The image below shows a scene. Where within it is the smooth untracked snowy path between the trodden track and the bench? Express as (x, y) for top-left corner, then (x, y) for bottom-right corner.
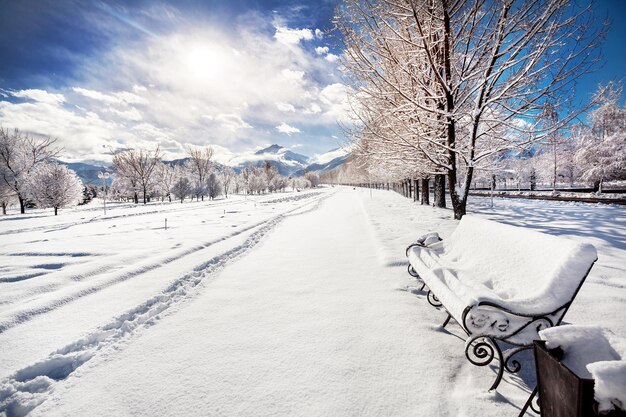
(7, 192), (468, 416)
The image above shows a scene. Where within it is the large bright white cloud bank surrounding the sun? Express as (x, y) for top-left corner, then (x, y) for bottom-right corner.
(0, 16), (343, 159)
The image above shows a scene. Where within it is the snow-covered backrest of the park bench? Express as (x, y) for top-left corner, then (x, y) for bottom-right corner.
(443, 216), (597, 312)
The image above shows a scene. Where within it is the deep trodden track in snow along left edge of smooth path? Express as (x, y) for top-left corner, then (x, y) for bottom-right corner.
(0, 193), (332, 417)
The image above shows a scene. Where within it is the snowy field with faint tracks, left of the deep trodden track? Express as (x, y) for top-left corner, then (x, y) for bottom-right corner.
(0, 193), (324, 390)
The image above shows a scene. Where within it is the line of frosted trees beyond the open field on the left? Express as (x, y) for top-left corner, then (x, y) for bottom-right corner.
(0, 127), (319, 215)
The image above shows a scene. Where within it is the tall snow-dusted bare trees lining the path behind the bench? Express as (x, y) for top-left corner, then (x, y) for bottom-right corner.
(335, 0), (607, 219)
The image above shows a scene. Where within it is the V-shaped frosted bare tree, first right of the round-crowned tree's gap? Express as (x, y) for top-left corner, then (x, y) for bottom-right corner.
(113, 145), (161, 204)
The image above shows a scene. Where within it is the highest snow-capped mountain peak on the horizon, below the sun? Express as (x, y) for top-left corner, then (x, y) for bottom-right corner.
(227, 144), (309, 177)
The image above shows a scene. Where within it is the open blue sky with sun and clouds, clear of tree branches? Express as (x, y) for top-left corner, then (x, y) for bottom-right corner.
(0, 0), (626, 161)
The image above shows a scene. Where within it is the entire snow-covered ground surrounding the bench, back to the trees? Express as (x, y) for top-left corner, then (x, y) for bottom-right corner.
(0, 187), (626, 416)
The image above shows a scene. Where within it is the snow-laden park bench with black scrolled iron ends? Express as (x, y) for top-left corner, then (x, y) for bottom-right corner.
(406, 216), (597, 389)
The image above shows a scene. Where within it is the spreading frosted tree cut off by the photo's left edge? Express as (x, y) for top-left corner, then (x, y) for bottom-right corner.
(0, 126), (60, 213)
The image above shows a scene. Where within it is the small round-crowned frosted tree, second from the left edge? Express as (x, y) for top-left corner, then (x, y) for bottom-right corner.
(26, 162), (83, 216)
